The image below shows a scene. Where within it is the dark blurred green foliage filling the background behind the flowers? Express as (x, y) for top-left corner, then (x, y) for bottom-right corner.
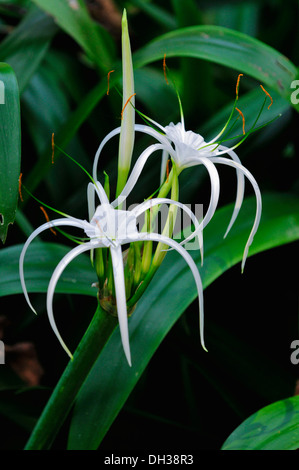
(0, 0), (299, 451)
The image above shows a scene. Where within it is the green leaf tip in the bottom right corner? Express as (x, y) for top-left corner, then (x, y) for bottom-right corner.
(222, 396), (299, 450)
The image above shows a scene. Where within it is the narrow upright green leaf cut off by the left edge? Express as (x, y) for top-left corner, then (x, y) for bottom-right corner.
(0, 63), (21, 243)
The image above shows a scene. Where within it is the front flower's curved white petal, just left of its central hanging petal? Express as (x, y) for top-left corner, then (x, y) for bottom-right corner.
(47, 242), (102, 359)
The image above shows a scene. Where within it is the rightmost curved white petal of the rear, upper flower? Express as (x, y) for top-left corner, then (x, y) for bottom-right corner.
(211, 157), (262, 272)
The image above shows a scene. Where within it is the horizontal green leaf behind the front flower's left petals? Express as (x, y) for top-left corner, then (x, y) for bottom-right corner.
(0, 243), (97, 298)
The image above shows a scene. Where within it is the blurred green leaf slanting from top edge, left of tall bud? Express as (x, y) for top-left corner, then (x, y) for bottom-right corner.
(33, 0), (113, 73)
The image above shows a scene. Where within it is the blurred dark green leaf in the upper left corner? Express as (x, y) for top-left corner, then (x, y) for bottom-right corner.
(0, 6), (57, 93)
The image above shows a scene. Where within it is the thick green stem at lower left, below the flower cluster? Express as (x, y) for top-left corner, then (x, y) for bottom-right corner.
(25, 304), (117, 450)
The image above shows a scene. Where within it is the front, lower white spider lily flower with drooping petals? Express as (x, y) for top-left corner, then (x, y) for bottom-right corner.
(19, 182), (206, 366)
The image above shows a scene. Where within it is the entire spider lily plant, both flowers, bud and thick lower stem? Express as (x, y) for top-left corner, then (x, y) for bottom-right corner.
(20, 12), (284, 449)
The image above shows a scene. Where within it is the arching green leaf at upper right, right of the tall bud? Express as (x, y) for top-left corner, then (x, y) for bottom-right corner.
(134, 25), (298, 107)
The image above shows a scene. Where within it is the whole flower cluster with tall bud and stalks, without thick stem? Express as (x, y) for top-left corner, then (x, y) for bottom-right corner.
(20, 12), (276, 372)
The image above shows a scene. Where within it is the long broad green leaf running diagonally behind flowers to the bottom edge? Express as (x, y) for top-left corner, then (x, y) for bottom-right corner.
(68, 194), (299, 450)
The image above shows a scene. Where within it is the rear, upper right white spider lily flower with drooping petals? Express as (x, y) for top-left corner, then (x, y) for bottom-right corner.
(93, 117), (262, 271)
